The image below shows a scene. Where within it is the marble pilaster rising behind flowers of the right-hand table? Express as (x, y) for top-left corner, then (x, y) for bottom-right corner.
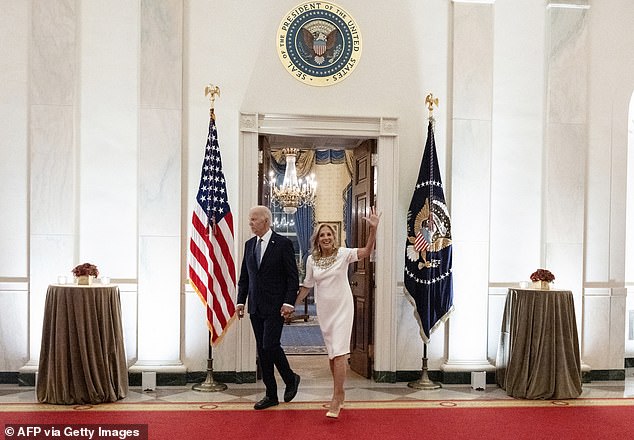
(543, 1), (589, 322)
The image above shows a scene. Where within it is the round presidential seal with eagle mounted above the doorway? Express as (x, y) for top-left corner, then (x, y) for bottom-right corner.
(277, 1), (362, 86)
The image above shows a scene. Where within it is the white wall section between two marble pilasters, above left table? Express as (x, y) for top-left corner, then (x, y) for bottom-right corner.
(79, 0), (142, 280)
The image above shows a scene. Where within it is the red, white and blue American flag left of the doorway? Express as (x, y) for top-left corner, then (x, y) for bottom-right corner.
(188, 109), (236, 345)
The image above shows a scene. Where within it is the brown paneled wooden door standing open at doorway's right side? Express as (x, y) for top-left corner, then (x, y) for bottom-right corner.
(350, 139), (376, 378)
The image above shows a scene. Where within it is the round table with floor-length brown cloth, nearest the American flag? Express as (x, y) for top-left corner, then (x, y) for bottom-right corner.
(36, 284), (128, 404)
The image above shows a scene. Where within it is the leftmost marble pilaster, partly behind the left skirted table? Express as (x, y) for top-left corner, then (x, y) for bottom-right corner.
(21, 0), (78, 372)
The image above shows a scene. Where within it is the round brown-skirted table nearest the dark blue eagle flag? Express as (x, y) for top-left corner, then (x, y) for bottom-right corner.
(496, 288), (581, 399)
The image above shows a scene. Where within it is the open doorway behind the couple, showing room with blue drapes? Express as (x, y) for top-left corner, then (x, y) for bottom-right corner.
(258, 135), (376, 370)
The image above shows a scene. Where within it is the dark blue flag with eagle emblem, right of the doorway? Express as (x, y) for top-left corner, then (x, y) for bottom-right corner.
(404, 118), (453, 343)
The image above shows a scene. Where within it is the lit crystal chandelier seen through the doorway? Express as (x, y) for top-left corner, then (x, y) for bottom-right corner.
(269, 148), (317, 214)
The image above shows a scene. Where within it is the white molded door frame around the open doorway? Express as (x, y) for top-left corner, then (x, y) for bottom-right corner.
(236, 112), (402, 373)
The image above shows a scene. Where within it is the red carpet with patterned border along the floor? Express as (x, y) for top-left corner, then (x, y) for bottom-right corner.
(0, 399), (634, 440)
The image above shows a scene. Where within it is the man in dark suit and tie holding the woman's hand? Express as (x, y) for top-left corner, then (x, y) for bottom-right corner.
(237, 206), (300, 409)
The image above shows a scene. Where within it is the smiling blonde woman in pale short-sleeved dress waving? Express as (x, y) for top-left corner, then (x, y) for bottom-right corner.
(297, 208), (380, 418)
